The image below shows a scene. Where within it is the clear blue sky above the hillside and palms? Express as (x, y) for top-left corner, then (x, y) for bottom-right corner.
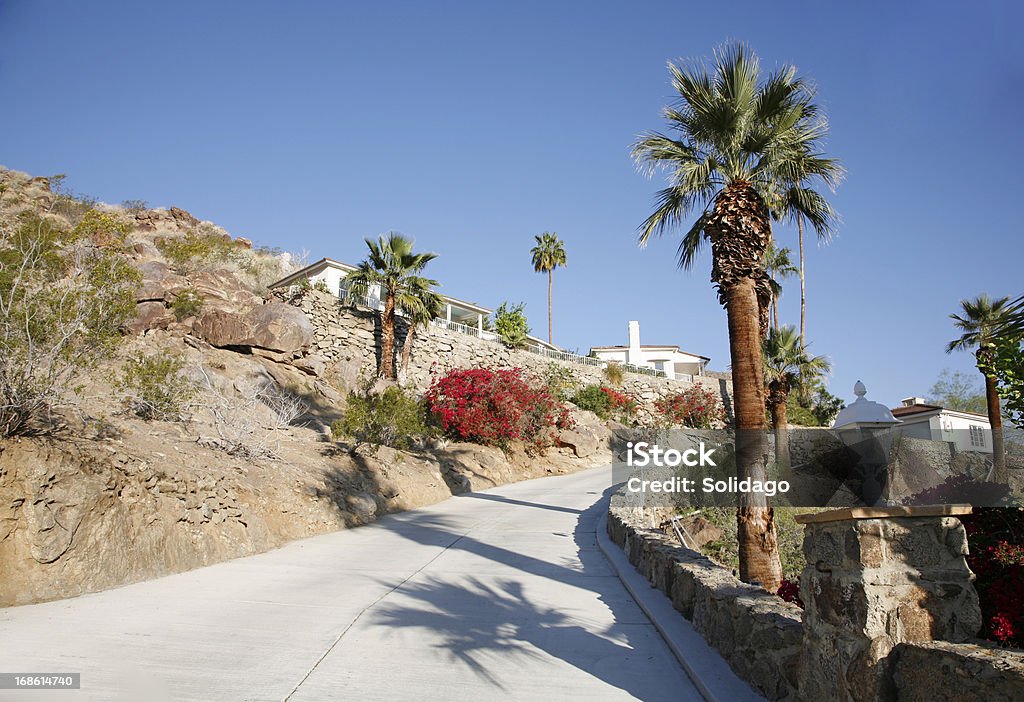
(0, 0), (1024, 403)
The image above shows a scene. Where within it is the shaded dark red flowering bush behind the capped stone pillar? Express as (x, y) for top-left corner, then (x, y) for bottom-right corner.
(961, 508), (1024, 648)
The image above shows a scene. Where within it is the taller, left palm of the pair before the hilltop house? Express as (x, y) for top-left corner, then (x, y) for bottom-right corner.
(344, 231), (437, 379)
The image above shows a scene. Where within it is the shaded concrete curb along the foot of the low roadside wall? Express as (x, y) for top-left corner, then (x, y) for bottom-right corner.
(597, 500), (765, 702)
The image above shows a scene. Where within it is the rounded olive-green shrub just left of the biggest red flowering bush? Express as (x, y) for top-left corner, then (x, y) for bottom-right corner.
(331, 387), (435, 448)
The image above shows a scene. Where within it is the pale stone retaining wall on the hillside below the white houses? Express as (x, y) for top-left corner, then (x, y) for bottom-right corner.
(280, 290), (732, 424)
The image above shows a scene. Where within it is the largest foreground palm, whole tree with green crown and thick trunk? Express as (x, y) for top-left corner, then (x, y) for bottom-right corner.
(633, 44), (831, 590)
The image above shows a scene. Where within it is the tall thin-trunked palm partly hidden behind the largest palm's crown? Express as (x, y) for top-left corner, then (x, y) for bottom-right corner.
(776, 151), (845, 346)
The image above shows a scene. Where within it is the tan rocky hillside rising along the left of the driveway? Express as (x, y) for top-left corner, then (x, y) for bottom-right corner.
(0, 169), (610, 606)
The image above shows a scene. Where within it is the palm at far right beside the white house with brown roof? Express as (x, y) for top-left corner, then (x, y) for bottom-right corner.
(946, 295), (1016, 483)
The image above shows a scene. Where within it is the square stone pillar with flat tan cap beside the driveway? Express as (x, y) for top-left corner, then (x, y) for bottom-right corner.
(797, 506), (981, 702)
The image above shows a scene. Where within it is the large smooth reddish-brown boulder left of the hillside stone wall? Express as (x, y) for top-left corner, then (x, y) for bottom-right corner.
(194, 302), (313, 353)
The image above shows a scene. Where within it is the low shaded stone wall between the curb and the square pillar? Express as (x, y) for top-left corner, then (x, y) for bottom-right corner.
(608, 492), (804, 700)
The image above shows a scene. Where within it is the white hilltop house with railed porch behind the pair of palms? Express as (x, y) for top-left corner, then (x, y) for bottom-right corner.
(269, 258), (561, 351)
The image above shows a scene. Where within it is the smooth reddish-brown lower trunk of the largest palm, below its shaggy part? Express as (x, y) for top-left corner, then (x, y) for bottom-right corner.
(726, 277), (782, 593)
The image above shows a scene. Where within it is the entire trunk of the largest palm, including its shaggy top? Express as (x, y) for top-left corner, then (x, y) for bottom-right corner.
(705, 181), (782, 593)
